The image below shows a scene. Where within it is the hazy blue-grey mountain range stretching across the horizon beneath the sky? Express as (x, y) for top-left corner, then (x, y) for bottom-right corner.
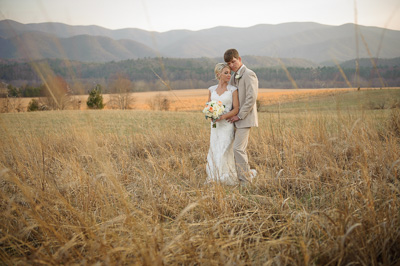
(0, 20), (400, 64)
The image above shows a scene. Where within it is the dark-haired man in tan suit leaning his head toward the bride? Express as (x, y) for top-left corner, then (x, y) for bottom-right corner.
(224, 49), (258, 184)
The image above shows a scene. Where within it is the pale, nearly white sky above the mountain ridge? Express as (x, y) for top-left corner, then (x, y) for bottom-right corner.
(0, 0), (400, 32)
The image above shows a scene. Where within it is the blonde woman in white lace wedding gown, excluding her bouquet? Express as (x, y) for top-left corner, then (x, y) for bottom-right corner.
(206, 63), (239, 185)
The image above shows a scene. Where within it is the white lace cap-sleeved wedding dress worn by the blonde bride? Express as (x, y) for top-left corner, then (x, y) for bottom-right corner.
(206, 85), (238, 185)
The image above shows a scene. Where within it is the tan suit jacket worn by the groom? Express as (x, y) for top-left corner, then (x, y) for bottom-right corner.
(230, 65), (258, 128)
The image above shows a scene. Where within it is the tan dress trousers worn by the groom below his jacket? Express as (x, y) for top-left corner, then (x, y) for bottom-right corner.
(233, 127), (250, 183)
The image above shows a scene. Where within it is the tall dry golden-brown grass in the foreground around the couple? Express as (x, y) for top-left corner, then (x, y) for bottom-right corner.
(0, 89), (400, 265)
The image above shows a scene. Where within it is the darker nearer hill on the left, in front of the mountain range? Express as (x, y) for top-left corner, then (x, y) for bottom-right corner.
(0, 32), (157, 62)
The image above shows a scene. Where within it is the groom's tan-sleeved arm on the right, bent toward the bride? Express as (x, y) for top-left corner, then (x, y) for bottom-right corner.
(238, 71), (258, 119)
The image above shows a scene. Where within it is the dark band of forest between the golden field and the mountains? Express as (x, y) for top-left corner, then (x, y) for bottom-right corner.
(0, 58), (400, 94)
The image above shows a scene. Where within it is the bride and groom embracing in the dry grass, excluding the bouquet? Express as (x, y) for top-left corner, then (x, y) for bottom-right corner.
(206, 49), (258, 185)
